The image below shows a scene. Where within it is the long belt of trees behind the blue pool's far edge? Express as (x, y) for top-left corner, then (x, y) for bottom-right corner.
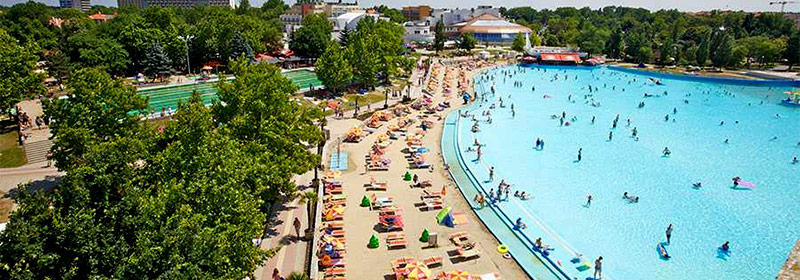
(500, 7), (800, 67)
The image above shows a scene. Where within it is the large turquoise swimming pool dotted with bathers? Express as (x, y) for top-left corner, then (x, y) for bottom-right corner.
(454, 66), (800, 279)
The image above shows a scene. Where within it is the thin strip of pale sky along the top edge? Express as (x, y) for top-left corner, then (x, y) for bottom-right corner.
(0, 0), (800, 12)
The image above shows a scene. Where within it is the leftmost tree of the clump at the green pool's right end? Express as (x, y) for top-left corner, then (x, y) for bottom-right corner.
(314, 44), (353, 93)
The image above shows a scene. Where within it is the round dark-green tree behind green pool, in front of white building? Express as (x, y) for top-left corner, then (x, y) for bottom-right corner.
(289, 14), (333, 58)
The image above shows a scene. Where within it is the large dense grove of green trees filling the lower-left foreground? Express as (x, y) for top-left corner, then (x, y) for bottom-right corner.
(0, 59), (322, 279)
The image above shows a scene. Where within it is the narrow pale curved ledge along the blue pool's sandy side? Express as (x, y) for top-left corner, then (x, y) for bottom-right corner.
(443, 75), (572, 279)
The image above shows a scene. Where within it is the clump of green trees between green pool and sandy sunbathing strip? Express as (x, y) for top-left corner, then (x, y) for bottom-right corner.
(306, 16), (406, 92)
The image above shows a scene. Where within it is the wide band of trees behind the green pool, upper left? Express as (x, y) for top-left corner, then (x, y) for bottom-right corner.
(0, 0), (287, 79)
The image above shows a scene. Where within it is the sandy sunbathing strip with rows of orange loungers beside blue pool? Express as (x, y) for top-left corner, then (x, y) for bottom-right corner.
(314, 57), (528, 279)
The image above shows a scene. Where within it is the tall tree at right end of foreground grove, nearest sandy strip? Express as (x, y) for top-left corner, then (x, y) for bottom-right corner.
(213, 59), (322, 201)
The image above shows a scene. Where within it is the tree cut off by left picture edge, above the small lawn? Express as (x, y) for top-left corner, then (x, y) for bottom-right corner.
(0, 29), (44, 113)
